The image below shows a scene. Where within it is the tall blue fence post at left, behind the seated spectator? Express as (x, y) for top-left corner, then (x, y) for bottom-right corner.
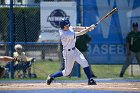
(10, 0), (14, 79)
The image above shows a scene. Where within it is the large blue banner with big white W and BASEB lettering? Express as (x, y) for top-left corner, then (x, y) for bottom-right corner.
(83, 0), (140, 64)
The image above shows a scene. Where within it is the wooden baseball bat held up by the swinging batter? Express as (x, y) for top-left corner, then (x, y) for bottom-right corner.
(89, 8), (118, 28)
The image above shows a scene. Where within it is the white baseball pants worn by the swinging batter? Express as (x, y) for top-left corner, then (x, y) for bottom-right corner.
(62, 48), (89, 76)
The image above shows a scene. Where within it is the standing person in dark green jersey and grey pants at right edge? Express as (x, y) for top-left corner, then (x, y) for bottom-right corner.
(120, 23), (140, 77)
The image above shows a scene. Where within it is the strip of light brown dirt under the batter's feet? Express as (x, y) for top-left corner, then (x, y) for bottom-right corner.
(0, 82), (140, 92)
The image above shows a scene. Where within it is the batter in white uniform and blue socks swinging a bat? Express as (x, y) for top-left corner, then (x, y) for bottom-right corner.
(46, 19), (96, 85)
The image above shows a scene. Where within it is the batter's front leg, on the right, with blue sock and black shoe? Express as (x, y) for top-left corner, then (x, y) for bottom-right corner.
(75, 49), (96, 85)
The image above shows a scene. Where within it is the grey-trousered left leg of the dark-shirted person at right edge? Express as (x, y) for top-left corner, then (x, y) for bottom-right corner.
(120, 52), (135, 77)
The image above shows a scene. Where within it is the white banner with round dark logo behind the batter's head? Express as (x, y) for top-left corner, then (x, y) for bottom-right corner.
(39, 2), (77, 42)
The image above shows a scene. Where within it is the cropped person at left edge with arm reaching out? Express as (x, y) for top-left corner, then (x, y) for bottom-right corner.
(0, 56), (14, 78)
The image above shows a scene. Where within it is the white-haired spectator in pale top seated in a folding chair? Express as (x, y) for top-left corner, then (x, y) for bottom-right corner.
(5, 44), (33, 78)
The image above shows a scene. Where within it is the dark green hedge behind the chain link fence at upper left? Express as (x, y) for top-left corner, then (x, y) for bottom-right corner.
(0, 7), (40, 42)
